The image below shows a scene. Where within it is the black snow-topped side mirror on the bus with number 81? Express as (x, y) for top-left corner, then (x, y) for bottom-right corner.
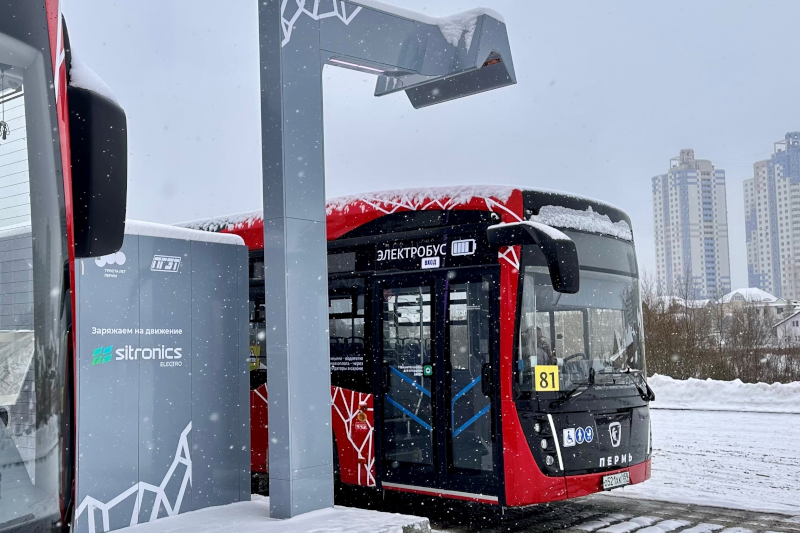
(486, 222), (580, 294)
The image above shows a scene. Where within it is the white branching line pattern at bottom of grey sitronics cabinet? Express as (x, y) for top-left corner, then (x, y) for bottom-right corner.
(75, 422), (192, 533)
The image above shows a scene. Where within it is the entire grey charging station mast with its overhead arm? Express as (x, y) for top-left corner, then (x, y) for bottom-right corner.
(259, 0), (516, 518)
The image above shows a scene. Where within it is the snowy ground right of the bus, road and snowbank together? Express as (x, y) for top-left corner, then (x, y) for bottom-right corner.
(611, 375), (800, 515)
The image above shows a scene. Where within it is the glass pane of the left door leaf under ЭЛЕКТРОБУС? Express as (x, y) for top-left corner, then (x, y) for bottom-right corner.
(381, 286), (434, 468)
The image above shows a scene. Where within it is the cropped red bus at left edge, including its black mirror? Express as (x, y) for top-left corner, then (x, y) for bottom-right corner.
(0, 0), (127, 531)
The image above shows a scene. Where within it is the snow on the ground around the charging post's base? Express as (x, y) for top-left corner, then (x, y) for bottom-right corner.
(123, 494), (430, 533)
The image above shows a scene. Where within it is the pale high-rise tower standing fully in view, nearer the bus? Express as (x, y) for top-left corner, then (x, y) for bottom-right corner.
(653, 149), (731, 298)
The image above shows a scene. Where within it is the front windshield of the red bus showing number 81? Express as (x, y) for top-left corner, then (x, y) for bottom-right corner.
(517, 231), (645, 393)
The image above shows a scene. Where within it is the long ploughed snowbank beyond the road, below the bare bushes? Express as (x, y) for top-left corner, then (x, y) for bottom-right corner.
(647, 374), (800, 414)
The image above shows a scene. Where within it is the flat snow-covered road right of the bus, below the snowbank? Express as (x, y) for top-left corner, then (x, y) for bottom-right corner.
(610, 409), (800, 515)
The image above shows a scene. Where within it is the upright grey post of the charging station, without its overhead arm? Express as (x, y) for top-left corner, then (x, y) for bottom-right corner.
(259, 1), (333, 518)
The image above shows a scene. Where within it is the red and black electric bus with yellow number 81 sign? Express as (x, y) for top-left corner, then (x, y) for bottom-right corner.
(186, 186), (654, 506)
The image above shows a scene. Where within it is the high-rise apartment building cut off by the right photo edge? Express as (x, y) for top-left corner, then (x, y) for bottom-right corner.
(744, 131), (800, 300)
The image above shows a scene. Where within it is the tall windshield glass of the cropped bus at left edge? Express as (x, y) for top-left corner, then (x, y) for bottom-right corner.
(0, 31), (69, 530)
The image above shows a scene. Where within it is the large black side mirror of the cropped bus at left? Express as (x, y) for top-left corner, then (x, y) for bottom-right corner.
(67, 85), (128, 257)
